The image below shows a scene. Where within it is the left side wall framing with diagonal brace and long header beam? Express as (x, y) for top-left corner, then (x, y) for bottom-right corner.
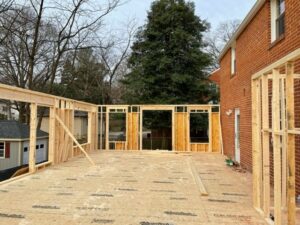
(0, 84), (98, 177)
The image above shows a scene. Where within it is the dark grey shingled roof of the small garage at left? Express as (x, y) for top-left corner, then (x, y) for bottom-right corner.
(0, 120), (48, 139)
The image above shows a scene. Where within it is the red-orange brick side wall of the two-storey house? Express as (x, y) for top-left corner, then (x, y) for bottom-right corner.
(218, 0), (300, 194)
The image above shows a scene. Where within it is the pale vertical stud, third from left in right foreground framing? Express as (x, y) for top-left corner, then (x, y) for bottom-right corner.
(272, 69), (282, 225)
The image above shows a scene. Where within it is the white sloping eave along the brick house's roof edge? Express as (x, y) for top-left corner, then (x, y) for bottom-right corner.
(218, 0), (266, 61)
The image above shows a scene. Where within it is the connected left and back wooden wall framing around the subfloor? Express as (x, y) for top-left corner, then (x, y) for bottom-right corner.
(0, 84), (222, 183)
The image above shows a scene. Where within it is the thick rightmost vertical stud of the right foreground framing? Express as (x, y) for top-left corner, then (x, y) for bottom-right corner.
(286, 62), (296, 225)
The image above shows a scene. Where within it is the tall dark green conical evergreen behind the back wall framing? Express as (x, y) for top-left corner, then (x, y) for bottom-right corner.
(124, 0), (212, 104)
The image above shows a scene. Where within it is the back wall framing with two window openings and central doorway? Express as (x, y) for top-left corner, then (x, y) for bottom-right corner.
(99, 105), (222, 153)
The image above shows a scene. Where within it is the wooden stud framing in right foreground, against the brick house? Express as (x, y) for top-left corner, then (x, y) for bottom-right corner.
(252, 49), (300, 225)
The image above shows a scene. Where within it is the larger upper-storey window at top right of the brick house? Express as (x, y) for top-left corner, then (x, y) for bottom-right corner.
(271, 0), (285, 42)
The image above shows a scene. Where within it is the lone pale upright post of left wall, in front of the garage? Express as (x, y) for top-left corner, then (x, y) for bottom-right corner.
(28, 103), (37, 173)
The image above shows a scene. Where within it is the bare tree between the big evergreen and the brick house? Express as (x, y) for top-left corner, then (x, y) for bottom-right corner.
(206, 20), (240, 70)
